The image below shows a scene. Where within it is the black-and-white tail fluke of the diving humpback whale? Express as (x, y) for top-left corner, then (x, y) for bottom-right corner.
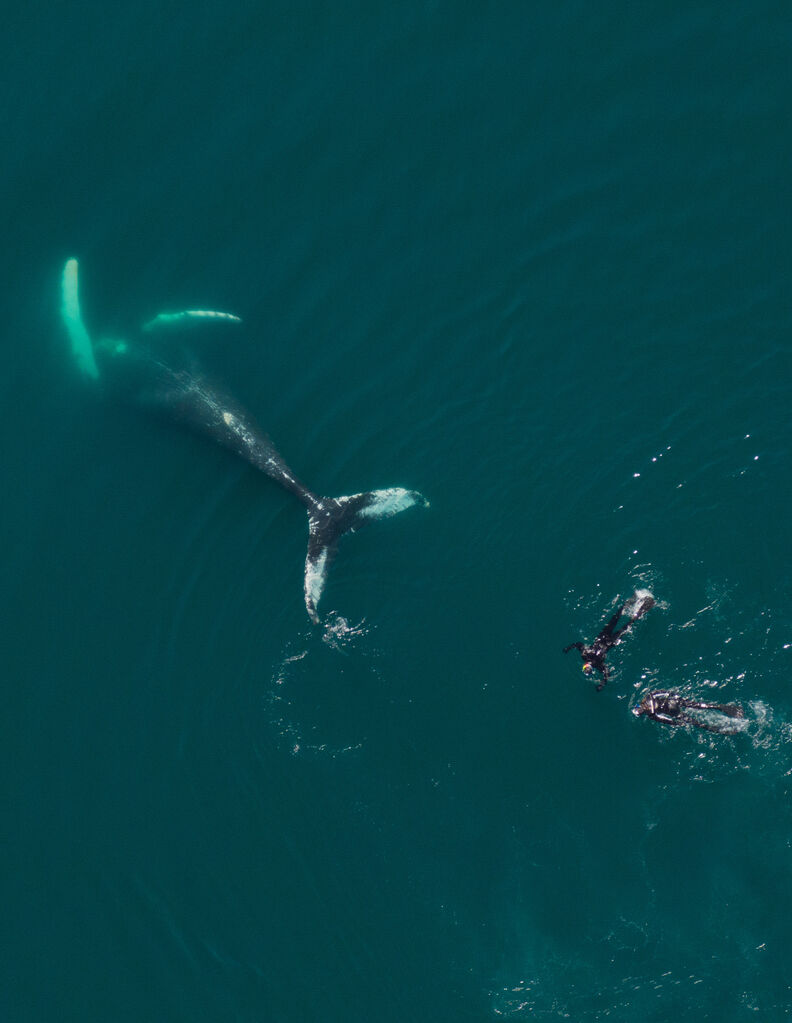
(305, 487), (429, 623)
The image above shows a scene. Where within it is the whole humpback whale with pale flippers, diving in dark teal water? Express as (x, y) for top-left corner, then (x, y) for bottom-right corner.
(61, 259), (429, 623)
